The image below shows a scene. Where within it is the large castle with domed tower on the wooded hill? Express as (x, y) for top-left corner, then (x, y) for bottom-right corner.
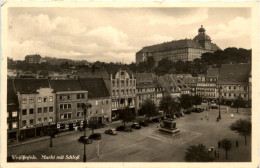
(136, 25), (221, 66)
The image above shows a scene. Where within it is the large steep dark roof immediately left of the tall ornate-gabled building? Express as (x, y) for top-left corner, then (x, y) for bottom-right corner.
(79, 78), (110, 99)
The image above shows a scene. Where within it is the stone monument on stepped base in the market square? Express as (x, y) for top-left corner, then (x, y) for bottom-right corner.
(159, 119), (180, 136)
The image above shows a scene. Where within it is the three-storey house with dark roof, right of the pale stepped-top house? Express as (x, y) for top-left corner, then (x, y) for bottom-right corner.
(49, 80), (88, 130)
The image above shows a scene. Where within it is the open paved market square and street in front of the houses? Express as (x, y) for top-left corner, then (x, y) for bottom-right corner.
(8, 107), (251, 162)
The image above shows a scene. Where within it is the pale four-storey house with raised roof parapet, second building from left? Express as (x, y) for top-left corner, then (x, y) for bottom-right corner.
(13, 79), (56, 139)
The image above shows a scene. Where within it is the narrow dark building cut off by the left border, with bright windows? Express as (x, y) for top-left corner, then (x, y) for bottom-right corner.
(7, 79), (19, 143)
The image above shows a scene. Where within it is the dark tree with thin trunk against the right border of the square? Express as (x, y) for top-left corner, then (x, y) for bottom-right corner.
(230, 119), (252, 145)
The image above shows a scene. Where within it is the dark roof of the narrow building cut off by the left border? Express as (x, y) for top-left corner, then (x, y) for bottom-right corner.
(7, 79), (19, 111)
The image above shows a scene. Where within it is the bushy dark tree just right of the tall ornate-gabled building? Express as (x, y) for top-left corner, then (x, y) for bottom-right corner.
(138, 99), (158, 120)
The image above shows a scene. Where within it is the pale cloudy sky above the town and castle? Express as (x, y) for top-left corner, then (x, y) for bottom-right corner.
(7, 7), (251, 63)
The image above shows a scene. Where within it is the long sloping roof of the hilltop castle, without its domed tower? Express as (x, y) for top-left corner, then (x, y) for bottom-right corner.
(137, 39), (220, 53)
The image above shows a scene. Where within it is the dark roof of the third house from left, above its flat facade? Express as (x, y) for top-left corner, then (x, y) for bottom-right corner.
(49, 80), (83, 92)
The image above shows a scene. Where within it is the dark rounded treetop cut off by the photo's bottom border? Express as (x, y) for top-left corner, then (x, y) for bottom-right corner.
(185, 144), (214, 162)
